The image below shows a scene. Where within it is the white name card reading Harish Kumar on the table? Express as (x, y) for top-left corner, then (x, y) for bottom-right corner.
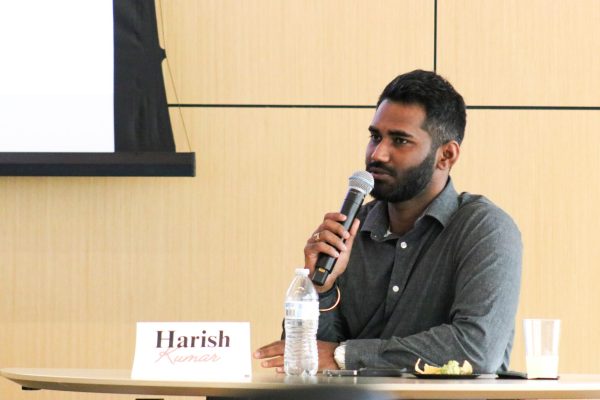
(131, 322), (252, 382)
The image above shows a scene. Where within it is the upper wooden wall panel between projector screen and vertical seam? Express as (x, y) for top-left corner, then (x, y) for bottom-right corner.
(161, 0), (434, 105)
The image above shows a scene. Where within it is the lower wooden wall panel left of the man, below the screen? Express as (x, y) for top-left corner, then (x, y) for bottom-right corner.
(0, 108), (372, 399)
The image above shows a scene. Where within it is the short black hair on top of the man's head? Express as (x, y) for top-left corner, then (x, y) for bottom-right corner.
(377, 70), (467, 148)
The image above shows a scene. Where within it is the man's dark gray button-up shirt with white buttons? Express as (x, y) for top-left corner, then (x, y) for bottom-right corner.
(318, 180), (522, 372)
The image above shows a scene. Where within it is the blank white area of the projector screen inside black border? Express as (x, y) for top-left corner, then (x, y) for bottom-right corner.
(0, 0), (115, 152)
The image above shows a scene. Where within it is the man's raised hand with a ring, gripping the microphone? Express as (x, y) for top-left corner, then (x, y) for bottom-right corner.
(304, 212), (360, 293)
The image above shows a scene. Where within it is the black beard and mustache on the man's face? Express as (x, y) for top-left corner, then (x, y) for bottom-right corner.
(367, 150), (436, 203)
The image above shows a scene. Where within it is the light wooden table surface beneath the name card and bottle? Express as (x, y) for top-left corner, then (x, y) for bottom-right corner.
(0, 368), (600, 399)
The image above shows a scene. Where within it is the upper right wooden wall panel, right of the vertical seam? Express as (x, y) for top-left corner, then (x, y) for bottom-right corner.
(437, 0), (600, 106)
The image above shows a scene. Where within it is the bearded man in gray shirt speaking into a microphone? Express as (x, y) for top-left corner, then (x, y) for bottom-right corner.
(255, 70), (522, 373)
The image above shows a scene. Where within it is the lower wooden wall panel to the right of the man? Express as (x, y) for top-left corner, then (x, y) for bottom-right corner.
(453, 110), (600, 373)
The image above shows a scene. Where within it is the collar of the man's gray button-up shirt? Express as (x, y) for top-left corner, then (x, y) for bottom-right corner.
(360, 178), (458, 236)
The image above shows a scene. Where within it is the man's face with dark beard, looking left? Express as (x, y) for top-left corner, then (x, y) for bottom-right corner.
(365, 100), (436, 203)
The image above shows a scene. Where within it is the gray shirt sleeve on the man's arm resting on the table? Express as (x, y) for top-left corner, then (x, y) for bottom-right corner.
(346, 207), (522, 373)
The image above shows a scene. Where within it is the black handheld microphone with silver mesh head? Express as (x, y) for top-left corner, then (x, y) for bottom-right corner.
(312, 171), (375, 286)
